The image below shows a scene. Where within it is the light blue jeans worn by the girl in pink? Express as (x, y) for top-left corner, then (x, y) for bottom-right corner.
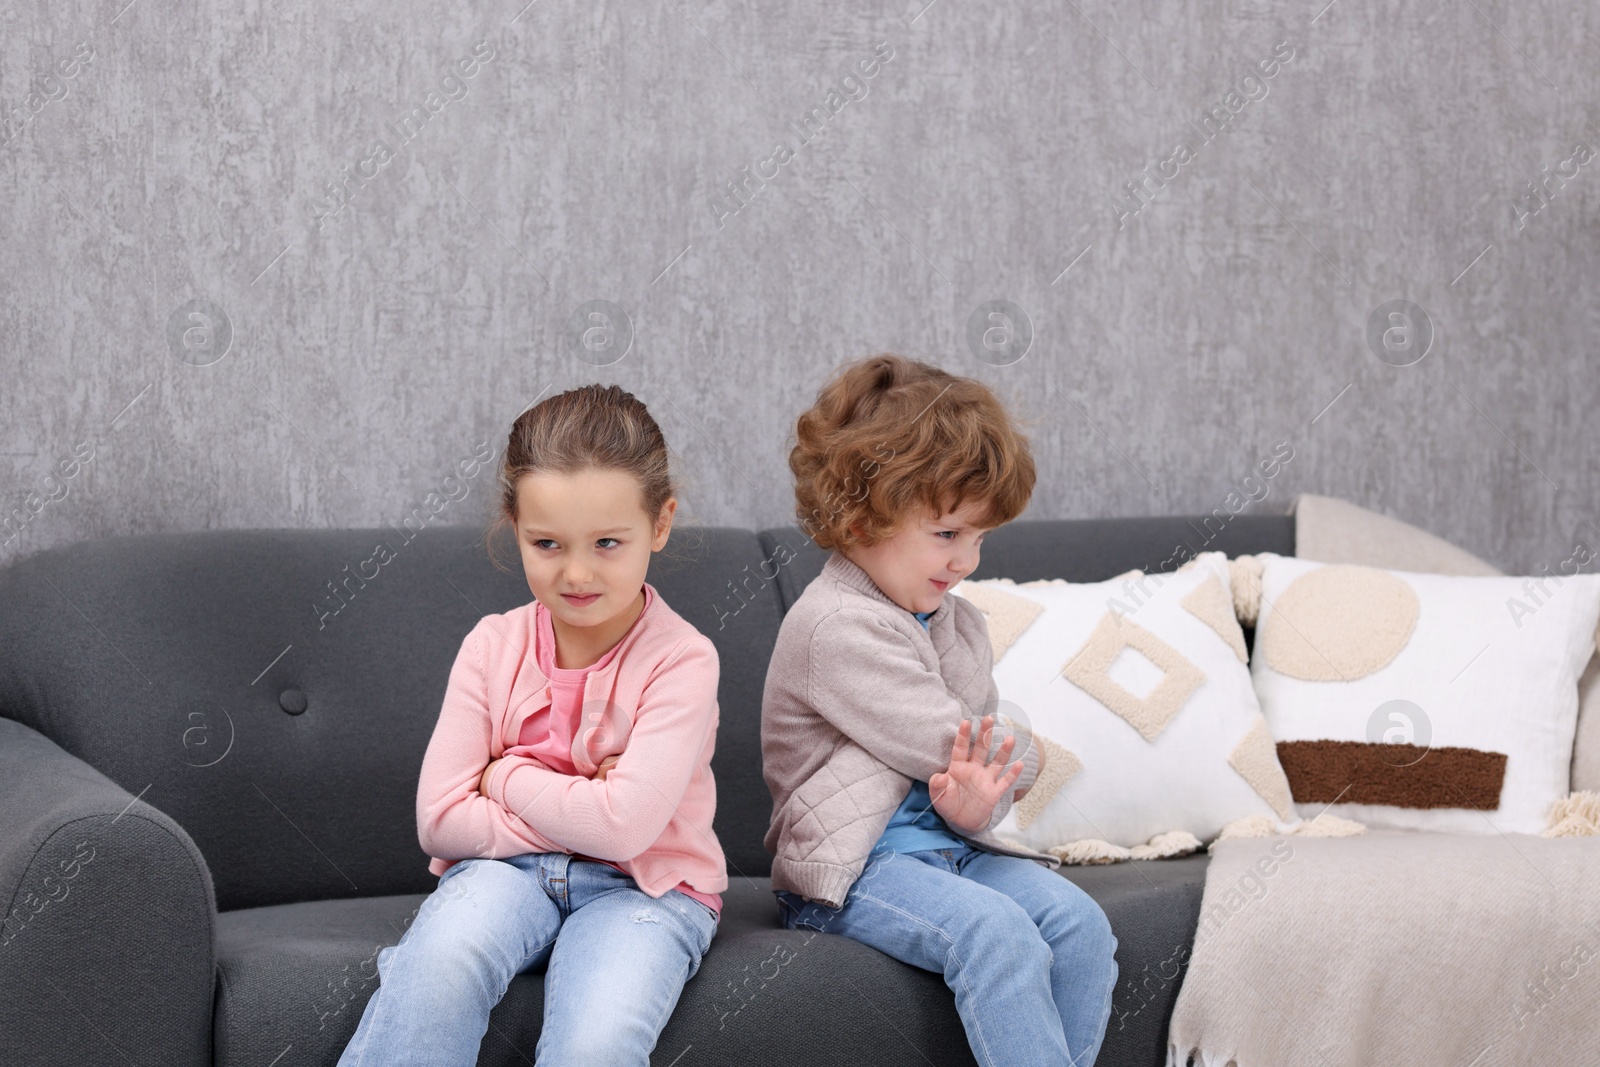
(339, 853), (717, 1067)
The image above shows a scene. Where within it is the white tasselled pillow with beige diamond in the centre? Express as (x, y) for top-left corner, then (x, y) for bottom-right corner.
(950, 552), (1296, 862)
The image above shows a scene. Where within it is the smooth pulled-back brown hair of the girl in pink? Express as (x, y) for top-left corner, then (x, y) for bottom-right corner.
(486, 384), (691, 569)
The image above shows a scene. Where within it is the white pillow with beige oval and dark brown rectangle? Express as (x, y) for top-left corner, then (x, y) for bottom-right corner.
(1251, 553), (1600, 833)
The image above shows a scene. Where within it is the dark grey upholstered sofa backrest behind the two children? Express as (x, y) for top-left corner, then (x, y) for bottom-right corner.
(0, 515), (1294, 910)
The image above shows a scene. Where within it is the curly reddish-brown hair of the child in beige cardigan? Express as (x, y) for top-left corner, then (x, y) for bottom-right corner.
(789, 352), (1035, 550)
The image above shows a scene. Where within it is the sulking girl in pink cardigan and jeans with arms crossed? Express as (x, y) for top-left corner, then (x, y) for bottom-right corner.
(339, 386), (728, 1067)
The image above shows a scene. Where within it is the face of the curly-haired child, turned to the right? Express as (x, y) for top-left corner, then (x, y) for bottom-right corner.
(845, 501), (989, 611)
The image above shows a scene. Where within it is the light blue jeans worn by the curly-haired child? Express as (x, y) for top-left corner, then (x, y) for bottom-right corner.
(776, 845), (1117, 1067)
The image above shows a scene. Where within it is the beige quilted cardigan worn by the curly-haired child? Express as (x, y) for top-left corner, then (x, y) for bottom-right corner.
(762, 552), (1061, 907)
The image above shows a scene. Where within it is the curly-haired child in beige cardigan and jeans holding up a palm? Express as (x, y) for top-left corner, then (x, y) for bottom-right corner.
(762, 355), (1117, 1067)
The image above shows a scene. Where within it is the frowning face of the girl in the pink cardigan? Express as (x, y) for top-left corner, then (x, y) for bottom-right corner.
(517, 467), (678, 638)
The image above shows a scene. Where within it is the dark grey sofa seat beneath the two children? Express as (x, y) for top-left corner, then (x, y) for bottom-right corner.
(214, 854), (1206, 1067)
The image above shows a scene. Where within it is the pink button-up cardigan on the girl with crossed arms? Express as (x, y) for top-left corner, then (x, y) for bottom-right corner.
(416, 587), (728, 897)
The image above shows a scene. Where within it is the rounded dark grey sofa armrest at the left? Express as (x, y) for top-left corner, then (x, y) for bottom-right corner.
(0, 718), (216, 1067)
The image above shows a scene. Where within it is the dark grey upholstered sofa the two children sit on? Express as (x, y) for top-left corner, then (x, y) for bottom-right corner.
(0, 512), (1294, 1067)
